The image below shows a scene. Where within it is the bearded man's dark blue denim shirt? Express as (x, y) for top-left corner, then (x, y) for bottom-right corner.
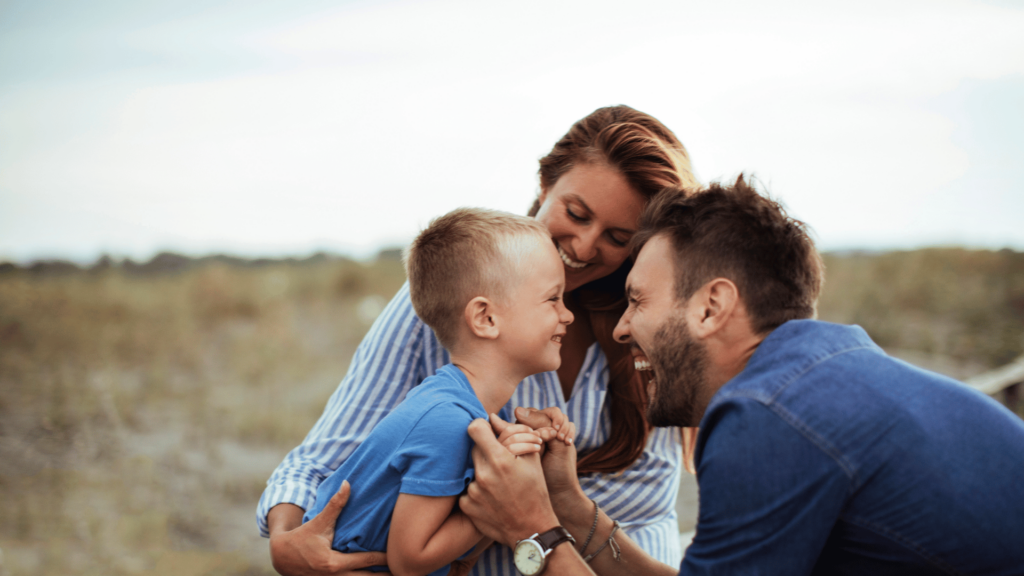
(681, 320), (1024, 576)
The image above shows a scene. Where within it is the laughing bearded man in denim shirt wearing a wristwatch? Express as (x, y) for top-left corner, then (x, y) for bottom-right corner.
(461, 177), (1024, 576)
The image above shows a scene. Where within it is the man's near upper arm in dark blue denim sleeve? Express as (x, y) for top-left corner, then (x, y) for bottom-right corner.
(683, 399), (853, 576)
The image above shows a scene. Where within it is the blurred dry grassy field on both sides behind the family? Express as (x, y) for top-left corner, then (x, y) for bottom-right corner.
(0, 245), (1024, 576)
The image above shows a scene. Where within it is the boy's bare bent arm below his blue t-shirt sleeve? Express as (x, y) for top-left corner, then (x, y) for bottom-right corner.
(387, 494), (483, 576)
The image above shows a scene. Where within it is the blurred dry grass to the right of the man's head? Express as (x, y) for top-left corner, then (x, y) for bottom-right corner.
(820, 248), (1024, 368)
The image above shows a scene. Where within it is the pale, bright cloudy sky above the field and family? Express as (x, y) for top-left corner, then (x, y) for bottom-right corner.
(0, 0), (1024, 262)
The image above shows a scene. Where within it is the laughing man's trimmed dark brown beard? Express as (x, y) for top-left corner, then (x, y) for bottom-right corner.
(644, 314), (708, 426)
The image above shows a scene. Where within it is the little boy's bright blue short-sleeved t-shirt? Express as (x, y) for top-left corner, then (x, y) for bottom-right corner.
(303, 364), (487, 575)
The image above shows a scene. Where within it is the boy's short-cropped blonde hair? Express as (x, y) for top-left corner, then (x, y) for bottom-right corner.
(404, 208), (551, 352)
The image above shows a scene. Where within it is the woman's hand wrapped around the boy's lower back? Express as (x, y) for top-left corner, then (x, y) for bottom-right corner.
(267, 481), (387, 576)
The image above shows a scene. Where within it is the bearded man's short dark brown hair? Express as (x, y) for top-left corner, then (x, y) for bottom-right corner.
(632, 174), (824, 334)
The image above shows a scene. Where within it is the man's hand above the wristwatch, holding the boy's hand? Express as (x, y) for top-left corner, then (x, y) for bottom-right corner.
(459, 419), (558, 546)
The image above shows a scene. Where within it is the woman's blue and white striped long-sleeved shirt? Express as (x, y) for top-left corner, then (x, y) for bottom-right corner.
(256, 284), (682, 576)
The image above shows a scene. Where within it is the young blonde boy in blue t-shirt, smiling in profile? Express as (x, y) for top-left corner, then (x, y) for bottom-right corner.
(304, 208), (572, 576)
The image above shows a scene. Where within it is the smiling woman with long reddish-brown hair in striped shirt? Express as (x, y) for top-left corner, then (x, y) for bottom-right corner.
(257, 106), (696, 575)
